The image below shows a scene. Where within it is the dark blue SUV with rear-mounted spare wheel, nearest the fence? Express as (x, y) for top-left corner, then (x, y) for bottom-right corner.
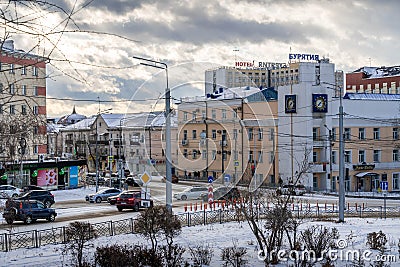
(3, 199), (57, 224)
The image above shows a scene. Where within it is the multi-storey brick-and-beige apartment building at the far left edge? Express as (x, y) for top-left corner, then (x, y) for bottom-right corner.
(0, 40), (47, 162)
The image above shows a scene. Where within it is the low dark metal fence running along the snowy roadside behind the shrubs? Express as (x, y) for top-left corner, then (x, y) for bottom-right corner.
(0, 205), (400, 251)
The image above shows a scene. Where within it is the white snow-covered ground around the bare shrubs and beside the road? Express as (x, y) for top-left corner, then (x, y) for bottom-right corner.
(0, 188), (400, 266)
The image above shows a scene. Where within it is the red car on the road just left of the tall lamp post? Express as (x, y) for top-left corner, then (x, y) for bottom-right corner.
(115, 191), (153, 211)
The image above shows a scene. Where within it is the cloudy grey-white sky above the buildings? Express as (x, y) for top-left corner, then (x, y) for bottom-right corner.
(6, 0), (400, 117)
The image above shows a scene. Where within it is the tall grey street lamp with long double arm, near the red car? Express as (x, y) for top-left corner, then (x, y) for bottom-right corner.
(133, 56), (172, 212)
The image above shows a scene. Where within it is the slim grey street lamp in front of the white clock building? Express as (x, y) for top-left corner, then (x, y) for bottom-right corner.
(323, 82), (345, 222)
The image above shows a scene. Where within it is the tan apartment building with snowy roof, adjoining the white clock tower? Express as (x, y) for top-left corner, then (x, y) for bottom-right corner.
(177, 87), (278, 186)
